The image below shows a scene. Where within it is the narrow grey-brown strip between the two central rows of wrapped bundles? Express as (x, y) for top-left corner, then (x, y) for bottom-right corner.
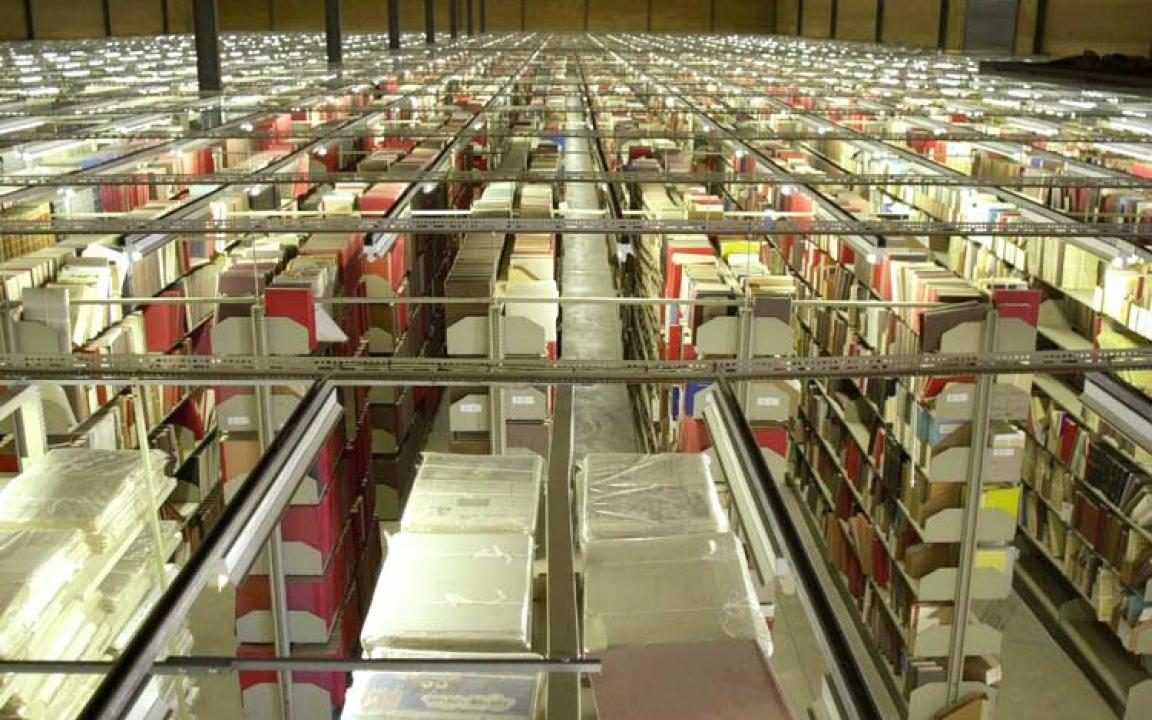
(544, 385), (581, 720)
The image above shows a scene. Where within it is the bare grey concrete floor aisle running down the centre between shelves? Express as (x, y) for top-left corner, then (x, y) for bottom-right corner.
(560, 106), (641, 453)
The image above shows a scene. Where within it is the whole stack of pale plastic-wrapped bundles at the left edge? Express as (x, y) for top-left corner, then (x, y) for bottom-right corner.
(0, 448), (180, 720)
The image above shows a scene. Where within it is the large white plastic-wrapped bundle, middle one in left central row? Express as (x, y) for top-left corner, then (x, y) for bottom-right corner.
(361, 532), (532, 657)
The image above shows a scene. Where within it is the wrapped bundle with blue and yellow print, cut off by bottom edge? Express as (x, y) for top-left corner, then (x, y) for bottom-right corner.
(340, 673), (540, 720)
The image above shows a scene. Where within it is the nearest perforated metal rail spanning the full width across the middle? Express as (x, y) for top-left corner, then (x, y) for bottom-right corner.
(0, 348), (1152, 386)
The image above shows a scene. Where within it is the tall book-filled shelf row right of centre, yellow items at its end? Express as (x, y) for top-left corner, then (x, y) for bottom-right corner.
(723, 126), (1022, 696)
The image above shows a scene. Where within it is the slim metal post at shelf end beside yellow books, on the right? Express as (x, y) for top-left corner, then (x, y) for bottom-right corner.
(940, 305), (996, 710)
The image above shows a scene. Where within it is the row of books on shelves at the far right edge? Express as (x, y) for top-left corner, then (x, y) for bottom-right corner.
(824, 112), (1152, 651)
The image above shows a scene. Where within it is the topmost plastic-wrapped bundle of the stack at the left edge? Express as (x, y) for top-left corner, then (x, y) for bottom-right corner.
(0, 448), (175, 533)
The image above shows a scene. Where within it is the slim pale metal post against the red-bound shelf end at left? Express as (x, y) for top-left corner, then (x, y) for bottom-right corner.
(251, 304), (295, 720)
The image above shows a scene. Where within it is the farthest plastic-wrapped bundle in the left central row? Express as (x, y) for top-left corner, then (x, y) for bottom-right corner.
(400, 453), (544, 535)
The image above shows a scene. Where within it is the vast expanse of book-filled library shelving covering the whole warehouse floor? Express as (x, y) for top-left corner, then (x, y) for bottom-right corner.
(0, 25), (1152, 720)
